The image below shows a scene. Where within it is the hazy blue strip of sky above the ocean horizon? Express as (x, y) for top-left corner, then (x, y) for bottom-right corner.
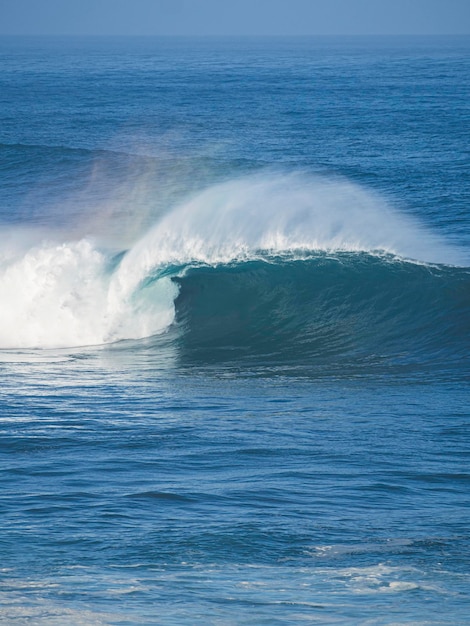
(0, 0), (470, 36)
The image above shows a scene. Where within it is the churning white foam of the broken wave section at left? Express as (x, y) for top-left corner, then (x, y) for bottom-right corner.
(0, 240), (177, 348)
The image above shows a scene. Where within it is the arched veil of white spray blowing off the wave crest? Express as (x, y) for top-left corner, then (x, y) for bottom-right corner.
(114, 174), (466, 294)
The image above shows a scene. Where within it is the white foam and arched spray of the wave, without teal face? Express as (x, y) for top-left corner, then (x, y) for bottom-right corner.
(0, 174), (465, 348)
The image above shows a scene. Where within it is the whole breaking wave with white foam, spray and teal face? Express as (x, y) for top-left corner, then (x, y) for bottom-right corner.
(0, 173), (470, 360)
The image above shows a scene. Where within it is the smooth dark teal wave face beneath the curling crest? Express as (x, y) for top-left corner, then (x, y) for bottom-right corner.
(176, 252), (470, 366)
